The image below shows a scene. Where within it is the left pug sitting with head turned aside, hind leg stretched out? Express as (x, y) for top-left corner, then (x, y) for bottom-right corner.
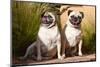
(20, 12), (63, 61)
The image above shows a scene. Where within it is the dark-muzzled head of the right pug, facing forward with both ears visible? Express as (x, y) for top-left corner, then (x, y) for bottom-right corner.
(68, 10), (84, 26)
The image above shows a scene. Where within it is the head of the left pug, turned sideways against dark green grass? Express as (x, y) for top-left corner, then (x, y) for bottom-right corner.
(41, 12), (55, 26)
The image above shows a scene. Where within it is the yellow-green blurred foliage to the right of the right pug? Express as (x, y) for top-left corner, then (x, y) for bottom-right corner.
(82, 16), (96, 54)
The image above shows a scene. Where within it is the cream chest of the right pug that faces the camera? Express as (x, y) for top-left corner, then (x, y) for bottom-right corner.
(65, 27), (81, 47)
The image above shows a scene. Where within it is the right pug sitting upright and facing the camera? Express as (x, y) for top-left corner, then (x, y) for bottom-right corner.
(64, 10), (84, 56)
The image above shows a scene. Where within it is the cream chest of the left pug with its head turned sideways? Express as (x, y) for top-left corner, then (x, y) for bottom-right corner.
(38, 27), (58, 49)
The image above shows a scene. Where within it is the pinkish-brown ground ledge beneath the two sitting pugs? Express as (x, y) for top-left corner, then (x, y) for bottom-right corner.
(12, 54), (96, 66)
